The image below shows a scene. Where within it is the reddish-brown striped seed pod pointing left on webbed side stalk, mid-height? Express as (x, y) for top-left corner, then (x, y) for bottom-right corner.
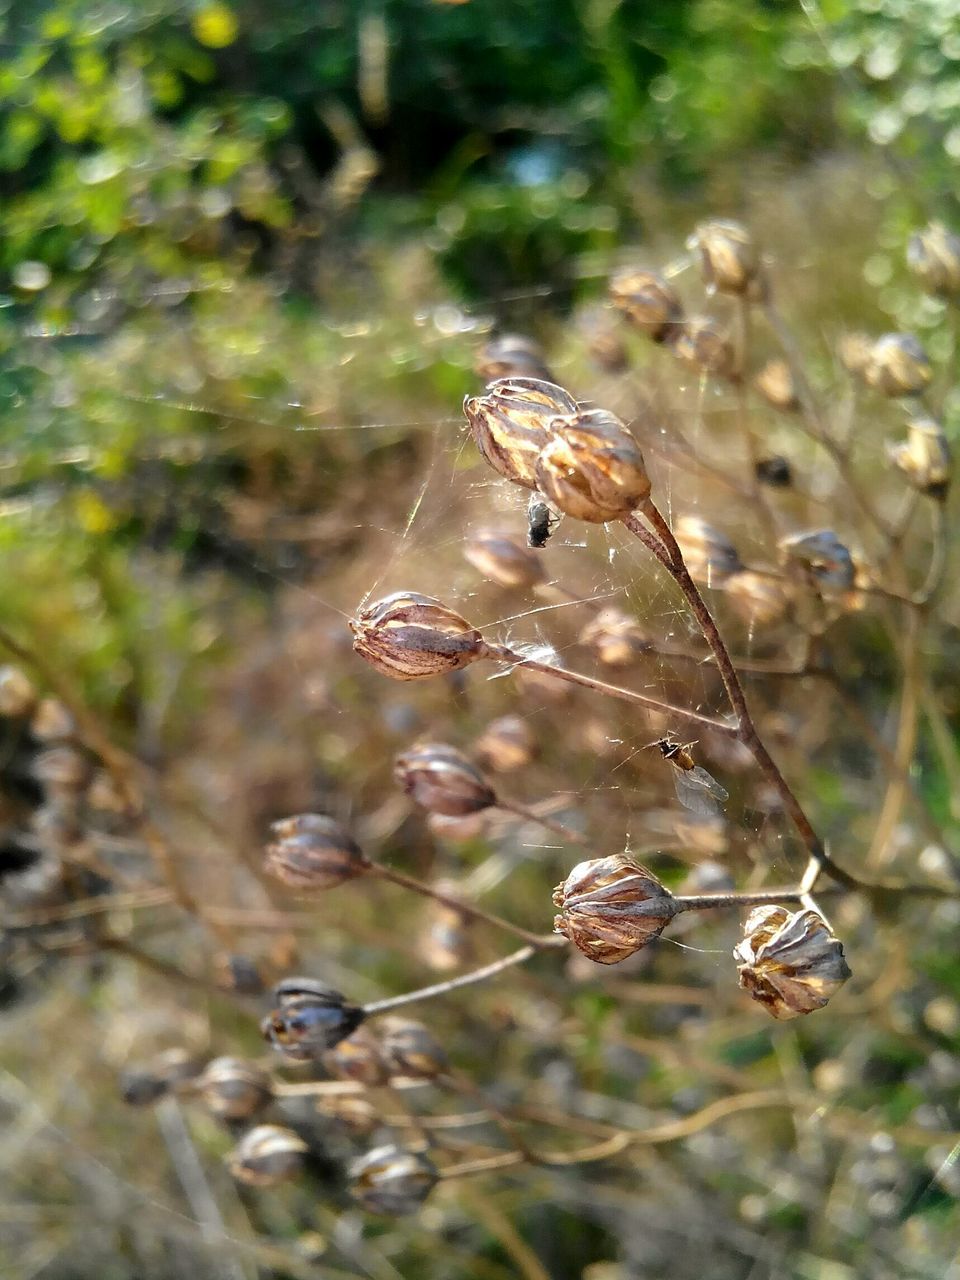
(349, 591), (484, 680)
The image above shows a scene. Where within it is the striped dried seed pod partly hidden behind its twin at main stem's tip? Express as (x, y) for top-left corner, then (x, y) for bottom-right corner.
(463, 378), (577, 489)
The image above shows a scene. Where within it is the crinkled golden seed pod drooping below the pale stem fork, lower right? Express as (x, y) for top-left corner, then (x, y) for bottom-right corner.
(733, 906), (850, 1019)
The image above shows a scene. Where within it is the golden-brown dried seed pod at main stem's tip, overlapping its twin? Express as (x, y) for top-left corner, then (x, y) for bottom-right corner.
(536, 408), (650, 524)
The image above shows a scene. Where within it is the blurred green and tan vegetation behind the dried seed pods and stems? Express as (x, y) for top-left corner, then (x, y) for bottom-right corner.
(0, 0), (960, 1280)
